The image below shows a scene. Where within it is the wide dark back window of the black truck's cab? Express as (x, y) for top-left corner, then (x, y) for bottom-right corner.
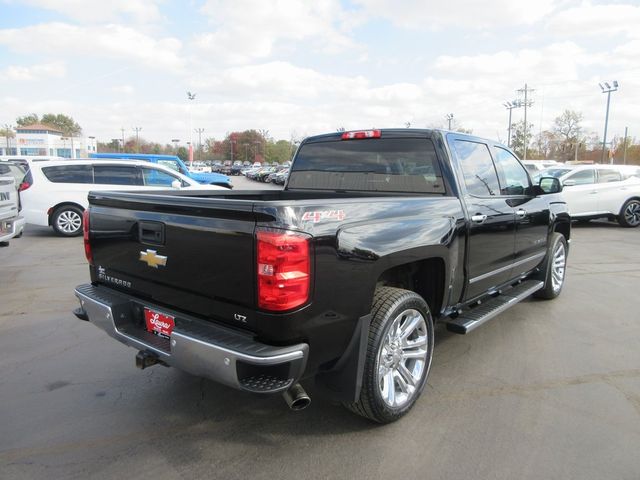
(288, 138), (445, 193)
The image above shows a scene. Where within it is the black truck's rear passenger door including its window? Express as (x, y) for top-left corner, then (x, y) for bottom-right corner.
(447, 135), (515, 300)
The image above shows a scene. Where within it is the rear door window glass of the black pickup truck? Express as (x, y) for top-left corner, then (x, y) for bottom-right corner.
(453, 140), (500, 197)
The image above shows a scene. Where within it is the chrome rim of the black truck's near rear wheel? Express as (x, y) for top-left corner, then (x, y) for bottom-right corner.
(376, 309), (429, 408)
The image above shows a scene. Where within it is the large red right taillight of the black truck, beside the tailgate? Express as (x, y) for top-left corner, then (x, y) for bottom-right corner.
(257, 230), (311, 312)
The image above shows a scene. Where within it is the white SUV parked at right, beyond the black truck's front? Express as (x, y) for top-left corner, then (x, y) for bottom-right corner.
(540, 165), (640, 227)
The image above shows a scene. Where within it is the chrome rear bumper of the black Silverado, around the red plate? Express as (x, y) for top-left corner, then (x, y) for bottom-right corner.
(75, 284), (309, 393)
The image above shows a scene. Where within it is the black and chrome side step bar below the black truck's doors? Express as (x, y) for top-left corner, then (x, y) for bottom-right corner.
(447, 280), (544, 335)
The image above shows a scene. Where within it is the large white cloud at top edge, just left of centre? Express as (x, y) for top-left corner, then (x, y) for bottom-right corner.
(194, 0), (355, 63)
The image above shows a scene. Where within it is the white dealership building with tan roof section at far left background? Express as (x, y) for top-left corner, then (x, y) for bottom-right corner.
(0, 123), (96, 158)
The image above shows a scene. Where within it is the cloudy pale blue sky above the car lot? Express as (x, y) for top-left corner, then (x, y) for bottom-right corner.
(0, 0), (640, 143)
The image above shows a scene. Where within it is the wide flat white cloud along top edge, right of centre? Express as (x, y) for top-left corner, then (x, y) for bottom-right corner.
(354, 0), (558, 29)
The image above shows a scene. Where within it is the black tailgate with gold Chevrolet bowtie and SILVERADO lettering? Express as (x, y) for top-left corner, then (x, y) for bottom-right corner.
(89, 192), (264, 315)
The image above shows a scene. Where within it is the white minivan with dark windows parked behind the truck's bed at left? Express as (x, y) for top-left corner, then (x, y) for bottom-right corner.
(20, 160), (226, 237)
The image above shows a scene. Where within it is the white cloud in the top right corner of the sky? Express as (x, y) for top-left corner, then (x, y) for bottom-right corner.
(546, 3), (640, 38)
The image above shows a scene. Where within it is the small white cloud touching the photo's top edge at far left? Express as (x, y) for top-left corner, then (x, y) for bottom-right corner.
(24, 0), (161, 24)
